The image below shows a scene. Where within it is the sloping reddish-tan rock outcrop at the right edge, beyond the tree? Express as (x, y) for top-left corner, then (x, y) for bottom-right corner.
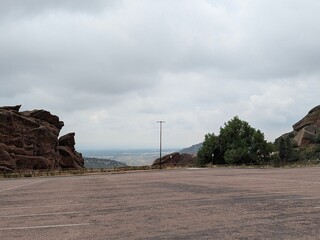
(281, 105), (320, 147)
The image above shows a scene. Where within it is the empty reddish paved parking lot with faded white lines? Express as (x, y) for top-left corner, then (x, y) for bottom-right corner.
(0, 167), (320, 240)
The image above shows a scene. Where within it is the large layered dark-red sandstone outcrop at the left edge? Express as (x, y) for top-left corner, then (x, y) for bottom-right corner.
(0, 106), (84, 170)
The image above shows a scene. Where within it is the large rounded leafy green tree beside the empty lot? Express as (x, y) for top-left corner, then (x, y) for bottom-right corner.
(198, 116), (272, 165)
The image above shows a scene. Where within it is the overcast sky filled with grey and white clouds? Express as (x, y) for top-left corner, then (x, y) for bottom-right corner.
(0, 0), (320, 149)
